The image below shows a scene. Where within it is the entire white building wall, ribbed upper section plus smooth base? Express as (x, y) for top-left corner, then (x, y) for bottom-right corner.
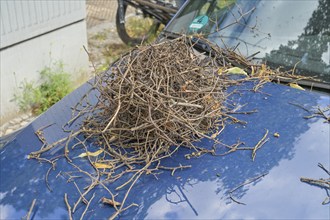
(0, 0), (88, 125)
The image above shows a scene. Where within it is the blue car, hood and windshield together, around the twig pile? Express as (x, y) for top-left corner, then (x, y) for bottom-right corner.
(0, 0), (330, 219)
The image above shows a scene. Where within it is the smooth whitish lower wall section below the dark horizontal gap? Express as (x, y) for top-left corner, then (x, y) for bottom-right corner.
(0, 20), (89, 126)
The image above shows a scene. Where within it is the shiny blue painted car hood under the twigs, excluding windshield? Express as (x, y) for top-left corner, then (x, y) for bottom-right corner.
(0, 80), (330, 219)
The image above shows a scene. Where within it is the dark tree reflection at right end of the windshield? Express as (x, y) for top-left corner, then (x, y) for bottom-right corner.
(265, 0), (330, 82)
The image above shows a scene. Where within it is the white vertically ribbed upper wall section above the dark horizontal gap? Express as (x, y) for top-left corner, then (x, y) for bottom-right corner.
(0, 0), (86, 48)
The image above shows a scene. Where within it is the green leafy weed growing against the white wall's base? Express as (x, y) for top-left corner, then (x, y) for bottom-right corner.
(14, 63), (72, 114)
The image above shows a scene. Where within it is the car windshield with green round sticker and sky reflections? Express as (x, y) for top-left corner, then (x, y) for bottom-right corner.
(166, 0), (330, 82)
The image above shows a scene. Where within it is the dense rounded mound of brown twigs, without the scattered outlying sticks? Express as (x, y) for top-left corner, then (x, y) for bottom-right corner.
(83, 37), (238, 163)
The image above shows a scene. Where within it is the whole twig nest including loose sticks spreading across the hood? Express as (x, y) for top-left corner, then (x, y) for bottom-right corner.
(30, 36), (306, 218)
